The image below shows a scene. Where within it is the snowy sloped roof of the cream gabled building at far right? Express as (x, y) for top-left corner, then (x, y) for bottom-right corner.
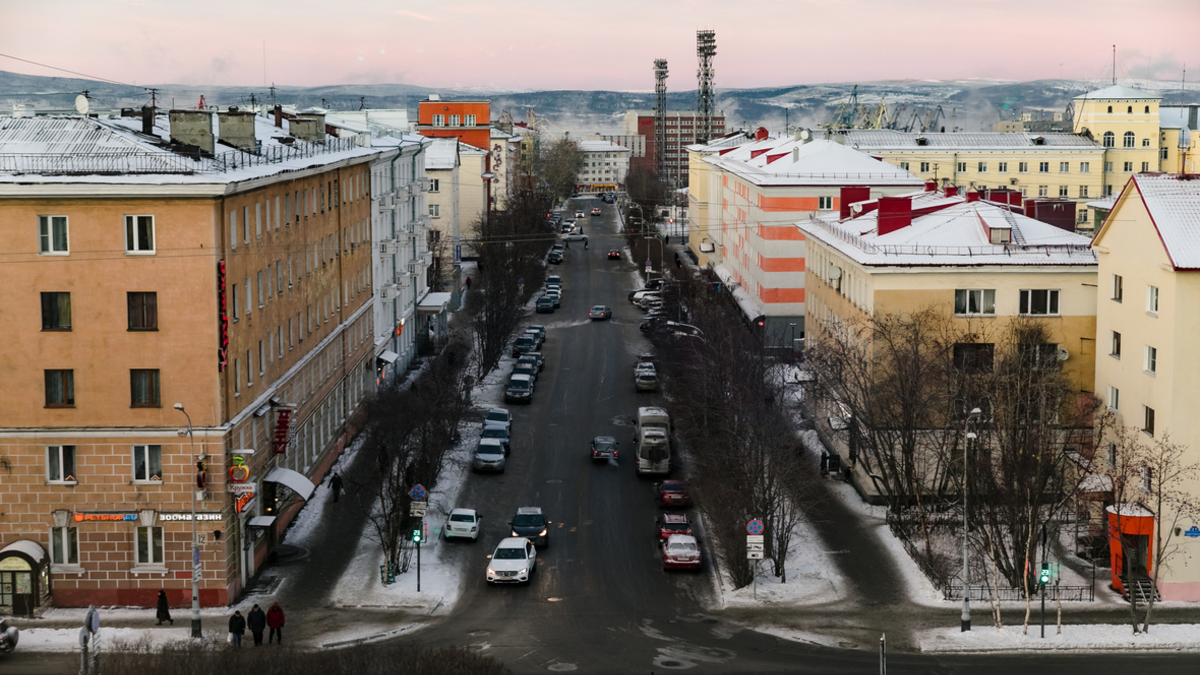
(1132, 173), (1200, 270)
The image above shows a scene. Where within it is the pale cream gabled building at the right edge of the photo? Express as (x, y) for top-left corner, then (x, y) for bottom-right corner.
(1092, 174), (1200, 601)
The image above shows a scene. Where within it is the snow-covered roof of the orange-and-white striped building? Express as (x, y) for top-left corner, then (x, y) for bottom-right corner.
(704, 137), (923, 186)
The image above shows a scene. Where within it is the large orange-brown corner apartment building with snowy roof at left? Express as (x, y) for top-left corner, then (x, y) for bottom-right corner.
(0, 108), (378, 613)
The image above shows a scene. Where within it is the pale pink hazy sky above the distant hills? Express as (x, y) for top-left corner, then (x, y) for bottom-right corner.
(0, 0), (1200, 90)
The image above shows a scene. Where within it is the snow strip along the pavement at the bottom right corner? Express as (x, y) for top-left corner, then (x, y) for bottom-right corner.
(918, 615), (1200, 652)
